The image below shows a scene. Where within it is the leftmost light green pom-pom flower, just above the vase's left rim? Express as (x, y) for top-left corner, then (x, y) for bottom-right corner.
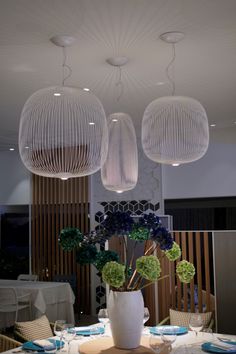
(102, 262), (125, 288)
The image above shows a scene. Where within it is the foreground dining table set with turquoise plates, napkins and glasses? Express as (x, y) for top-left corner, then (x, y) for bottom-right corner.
(6, 320), (236, 354)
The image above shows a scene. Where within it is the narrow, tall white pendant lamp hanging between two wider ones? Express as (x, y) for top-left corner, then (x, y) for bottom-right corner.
(101, 57), (138, 193)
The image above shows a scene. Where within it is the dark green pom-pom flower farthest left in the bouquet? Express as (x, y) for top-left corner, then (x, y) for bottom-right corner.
(59, 227), (84, 251)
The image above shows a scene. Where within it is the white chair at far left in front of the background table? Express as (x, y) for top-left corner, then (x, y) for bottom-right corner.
(0, 288), (31, 322)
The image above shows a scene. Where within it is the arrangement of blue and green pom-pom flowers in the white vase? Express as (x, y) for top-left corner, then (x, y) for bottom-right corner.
(59, 212), (195, 291)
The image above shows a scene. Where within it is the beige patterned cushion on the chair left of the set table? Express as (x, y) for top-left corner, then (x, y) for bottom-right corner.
(14, 315), (54, 342)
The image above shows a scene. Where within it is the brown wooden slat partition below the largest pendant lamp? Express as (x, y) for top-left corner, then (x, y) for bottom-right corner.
(31, 175), (90, 314)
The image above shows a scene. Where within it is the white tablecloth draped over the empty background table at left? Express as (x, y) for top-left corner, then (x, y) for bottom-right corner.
(0, 279), (75, 328)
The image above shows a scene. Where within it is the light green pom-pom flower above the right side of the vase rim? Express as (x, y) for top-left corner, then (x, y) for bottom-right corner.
(136, 256), (161, 281)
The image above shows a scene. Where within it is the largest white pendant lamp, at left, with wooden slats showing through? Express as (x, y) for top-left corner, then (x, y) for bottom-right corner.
(19, 36), (108, 179)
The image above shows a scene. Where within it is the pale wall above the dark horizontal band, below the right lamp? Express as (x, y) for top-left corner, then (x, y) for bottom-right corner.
(162, 142), (236, 199)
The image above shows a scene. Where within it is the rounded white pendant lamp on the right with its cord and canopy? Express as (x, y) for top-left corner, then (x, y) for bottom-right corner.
(142, 32), (209, 165)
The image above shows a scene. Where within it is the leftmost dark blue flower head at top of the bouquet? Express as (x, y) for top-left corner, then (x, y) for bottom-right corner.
(101, 211), (134, 236)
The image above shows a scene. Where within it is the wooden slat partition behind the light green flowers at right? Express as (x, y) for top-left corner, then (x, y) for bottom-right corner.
(158, 231), (214, 321)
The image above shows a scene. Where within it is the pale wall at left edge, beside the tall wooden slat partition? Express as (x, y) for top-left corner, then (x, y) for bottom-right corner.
(0, 151), (30, 205)
